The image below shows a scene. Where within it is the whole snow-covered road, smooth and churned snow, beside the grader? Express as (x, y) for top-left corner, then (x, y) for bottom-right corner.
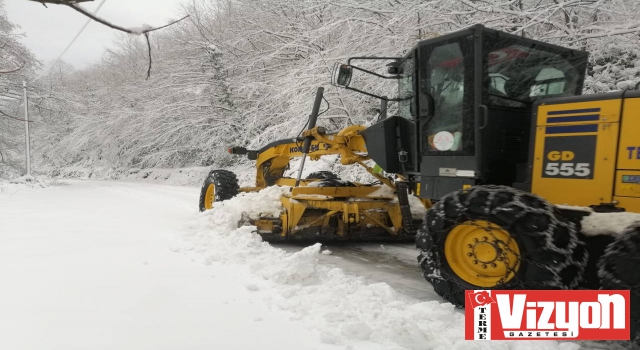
(0, 181), (624, 350)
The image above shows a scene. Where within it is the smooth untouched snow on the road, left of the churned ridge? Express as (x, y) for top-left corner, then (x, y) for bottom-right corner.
(0, 181), (335, 350)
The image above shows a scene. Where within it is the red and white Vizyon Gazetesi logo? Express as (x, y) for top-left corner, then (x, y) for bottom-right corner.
(465, 290), (630, 340)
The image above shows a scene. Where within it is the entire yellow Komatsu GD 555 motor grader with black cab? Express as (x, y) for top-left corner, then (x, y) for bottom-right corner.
(200, 25), (640, 328)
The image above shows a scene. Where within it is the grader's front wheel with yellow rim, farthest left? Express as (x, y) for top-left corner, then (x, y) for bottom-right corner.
(199, 170), (240, 211)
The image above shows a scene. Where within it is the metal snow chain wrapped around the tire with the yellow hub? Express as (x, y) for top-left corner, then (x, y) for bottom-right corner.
(416, 186), (588, 307)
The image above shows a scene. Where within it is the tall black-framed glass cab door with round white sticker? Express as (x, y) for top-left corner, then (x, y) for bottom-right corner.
(418, 31), (477, 199)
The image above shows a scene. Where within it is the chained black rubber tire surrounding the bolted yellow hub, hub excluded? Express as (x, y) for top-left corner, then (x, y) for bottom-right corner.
(416, 186), (588, 308)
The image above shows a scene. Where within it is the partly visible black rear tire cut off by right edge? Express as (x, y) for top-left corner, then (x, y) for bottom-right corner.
(598, 224), (640, 343)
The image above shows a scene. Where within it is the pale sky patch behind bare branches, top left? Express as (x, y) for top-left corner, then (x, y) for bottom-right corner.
(4, 0), (182, 68)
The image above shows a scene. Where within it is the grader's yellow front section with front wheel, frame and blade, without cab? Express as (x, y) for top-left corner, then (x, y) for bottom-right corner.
(200, 87), (429, 241)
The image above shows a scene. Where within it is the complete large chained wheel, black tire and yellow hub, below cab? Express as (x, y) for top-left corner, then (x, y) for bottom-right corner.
(416, 186), (588, 308)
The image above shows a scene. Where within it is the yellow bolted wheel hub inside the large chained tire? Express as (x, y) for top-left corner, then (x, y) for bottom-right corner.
(444, 220), (520, 287)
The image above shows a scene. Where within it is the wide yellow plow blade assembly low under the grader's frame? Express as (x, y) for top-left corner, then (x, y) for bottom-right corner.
(239, 186), (421, 242)
